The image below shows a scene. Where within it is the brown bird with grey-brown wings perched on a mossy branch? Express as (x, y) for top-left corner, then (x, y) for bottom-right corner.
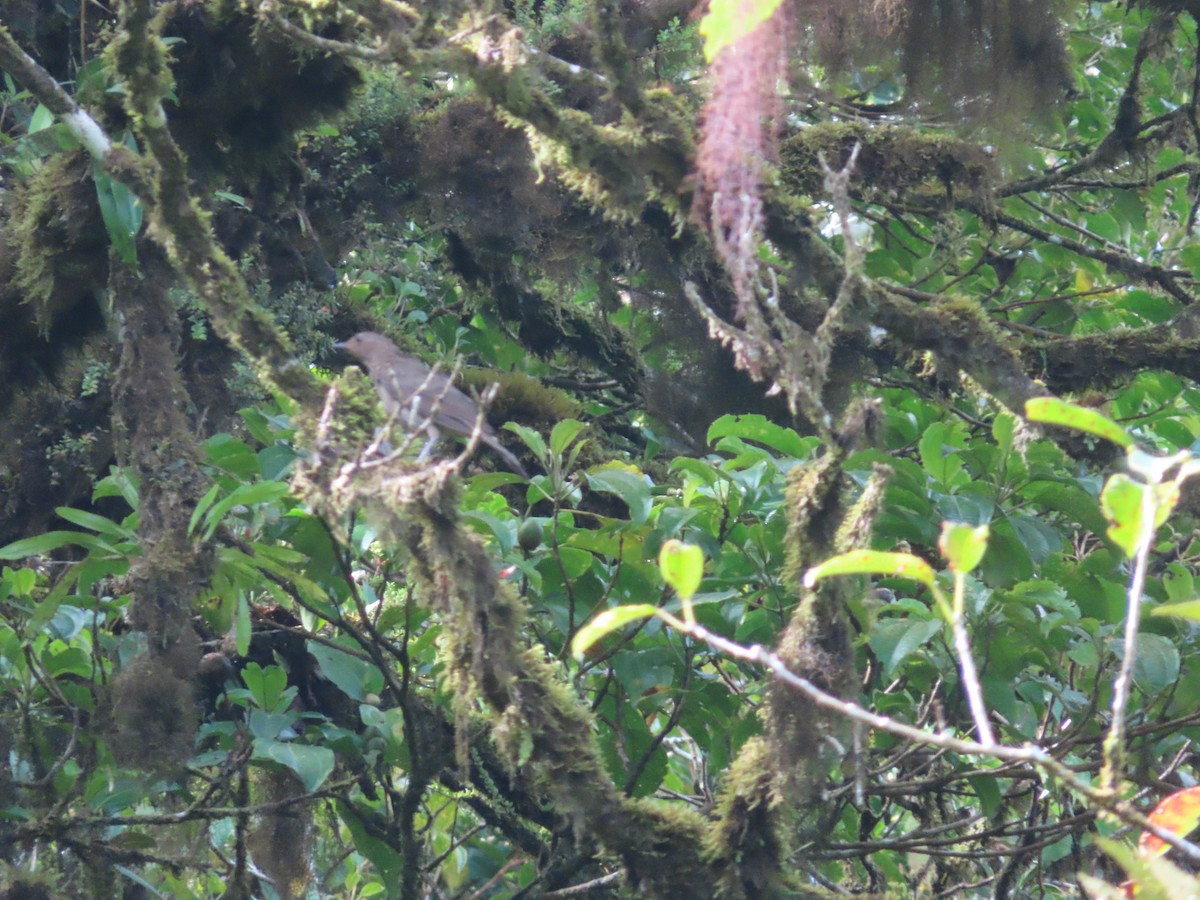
(334, 331), (529, 478)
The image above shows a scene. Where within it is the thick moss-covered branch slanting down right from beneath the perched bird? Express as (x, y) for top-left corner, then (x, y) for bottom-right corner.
(294, 422), (714, 898)
